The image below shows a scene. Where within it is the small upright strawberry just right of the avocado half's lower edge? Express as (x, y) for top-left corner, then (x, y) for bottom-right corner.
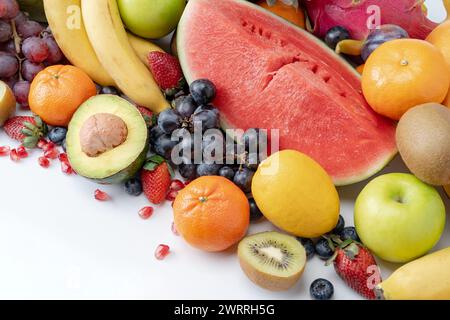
(141, 156), (172, 204)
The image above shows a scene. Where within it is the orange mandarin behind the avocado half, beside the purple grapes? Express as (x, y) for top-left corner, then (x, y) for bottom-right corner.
(28, 65), (97, 127)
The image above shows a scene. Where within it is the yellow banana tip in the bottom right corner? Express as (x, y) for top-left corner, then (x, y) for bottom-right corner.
(375, 248), (450, 300)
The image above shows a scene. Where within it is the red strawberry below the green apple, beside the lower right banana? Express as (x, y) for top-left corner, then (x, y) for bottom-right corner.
(327, 239), (381, 300)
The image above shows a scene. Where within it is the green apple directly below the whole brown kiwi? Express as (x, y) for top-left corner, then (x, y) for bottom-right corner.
(355, 173), (445, 263)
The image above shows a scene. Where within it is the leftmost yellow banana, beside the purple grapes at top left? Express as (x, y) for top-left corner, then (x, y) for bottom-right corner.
(44, 0), (114, 86)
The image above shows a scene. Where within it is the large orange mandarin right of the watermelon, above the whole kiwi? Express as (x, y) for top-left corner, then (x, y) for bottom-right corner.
(362, 39), (450, 120)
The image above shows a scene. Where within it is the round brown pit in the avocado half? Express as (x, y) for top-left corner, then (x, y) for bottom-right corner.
(80, 113), (128, 157)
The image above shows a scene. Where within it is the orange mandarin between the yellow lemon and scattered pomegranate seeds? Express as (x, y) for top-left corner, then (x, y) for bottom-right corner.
(173, 177), (250, 252)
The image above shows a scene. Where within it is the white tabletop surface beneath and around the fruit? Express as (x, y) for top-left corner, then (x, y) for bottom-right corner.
(0, 0), (450, 299)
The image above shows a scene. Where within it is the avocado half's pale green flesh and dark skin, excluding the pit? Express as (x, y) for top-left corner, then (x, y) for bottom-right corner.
(66, 94), (148, 184)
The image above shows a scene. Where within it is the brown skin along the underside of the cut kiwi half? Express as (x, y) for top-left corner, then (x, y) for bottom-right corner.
(239, 257), (305, 291)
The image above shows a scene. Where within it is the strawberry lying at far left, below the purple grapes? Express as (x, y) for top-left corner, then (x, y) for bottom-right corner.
(3, 116), (48, 149)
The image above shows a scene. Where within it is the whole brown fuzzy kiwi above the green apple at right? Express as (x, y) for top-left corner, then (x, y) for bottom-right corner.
(396, 103), (450, 186)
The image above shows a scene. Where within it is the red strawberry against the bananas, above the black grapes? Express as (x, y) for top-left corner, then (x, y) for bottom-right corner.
(148, 51), (185, 96)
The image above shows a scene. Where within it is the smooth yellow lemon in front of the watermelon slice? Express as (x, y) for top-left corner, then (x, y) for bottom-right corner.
(252, 150), (339, 238)
